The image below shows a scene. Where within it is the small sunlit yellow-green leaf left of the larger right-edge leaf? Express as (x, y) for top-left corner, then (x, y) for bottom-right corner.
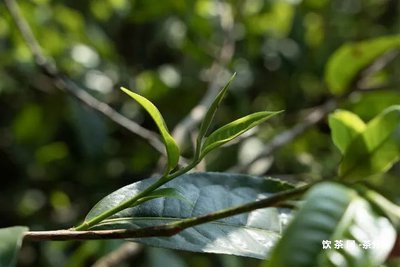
(329, 110), (365, 154)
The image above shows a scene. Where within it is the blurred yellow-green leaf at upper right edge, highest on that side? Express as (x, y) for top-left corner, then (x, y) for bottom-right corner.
(325, 35), (400, 95)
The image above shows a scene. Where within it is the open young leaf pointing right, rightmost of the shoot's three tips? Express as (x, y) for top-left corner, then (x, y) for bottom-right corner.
(200, 111), (282, 158)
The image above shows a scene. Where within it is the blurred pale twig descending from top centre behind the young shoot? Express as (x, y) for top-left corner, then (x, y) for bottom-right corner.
(172, 0), (235, 149)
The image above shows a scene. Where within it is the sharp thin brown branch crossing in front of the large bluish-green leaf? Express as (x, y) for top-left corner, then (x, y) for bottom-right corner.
(24, 184), (312, 241)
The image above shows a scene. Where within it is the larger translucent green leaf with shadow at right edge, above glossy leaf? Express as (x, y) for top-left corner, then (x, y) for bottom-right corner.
(339, 106), (400, 180)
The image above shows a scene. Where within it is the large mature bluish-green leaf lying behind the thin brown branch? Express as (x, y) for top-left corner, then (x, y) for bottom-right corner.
(86, 172), (292, 258)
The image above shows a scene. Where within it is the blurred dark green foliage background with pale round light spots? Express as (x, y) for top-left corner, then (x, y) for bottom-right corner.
(0, 0), (400, 267)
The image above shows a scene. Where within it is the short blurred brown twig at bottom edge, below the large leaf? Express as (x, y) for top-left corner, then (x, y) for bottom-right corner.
(92, 242), (143, 267)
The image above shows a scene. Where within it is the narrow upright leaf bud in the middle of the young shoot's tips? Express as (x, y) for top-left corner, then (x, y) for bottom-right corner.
(196, 72), (236, 156)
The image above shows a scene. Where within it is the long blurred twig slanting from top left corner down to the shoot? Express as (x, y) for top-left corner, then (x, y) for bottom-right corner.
(4, 0), (186, 164)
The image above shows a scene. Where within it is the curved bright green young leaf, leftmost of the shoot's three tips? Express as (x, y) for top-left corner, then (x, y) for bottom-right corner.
(121, 87), (179, 173)
